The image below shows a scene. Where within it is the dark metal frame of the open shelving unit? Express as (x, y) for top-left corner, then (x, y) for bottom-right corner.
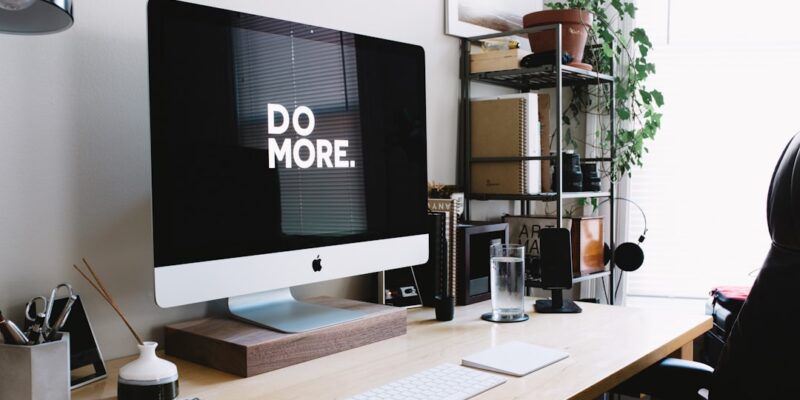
(459, 24), (616, 304)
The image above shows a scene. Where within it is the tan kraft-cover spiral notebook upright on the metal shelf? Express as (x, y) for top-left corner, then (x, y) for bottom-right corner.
(470, 93), (541, 194)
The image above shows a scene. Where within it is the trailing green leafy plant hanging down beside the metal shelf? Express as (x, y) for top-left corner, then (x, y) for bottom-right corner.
(545, 0), (664, 180)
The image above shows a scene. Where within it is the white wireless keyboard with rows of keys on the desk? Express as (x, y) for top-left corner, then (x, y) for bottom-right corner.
(350, 364), (506, 400)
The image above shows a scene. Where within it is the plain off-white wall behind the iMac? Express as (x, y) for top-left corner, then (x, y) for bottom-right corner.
(0, 0), (466, 358)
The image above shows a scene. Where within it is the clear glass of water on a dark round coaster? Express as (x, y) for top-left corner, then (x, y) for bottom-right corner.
(483, 243), (528, 322)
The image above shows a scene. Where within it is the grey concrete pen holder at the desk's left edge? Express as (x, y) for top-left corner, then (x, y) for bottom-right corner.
(0, 333), (70, 400)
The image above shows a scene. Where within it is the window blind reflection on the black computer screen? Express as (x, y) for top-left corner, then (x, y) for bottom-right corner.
(232, 20), (367, 236)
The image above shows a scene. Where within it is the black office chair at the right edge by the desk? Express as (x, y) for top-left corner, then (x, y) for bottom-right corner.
(615, 134), (800, 400)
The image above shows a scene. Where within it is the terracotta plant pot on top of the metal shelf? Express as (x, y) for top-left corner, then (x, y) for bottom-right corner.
(522, 9), (593, 64)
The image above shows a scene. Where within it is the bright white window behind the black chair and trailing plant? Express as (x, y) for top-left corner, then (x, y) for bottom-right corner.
(628, 0), (800, 298)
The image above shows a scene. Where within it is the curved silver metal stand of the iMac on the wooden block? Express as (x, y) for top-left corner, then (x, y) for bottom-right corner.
(223, 288), (365, 333)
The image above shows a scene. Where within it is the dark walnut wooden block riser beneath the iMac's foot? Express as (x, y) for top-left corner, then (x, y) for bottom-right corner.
(165, 297), (406, 377)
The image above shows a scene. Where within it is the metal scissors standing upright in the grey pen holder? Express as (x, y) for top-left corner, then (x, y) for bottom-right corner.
(25, 283), (78, 344)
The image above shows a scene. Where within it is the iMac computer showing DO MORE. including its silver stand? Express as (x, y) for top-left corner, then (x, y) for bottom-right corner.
(148, 0), (428, 332)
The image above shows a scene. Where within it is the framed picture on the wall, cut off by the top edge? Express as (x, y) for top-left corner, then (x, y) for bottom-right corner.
(445, 0), (544, 37)
